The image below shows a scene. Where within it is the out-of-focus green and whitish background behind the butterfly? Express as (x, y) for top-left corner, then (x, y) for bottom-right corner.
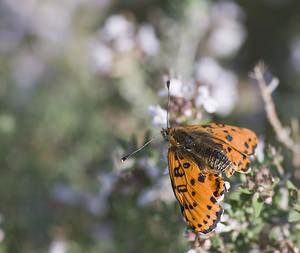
(0, 0), (300, 253)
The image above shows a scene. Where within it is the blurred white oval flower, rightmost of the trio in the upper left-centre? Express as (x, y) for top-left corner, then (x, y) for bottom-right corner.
(137, 25), (159, 55)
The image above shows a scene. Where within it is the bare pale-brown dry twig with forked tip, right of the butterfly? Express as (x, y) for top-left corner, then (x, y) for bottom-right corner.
(251, 62), (300, 167)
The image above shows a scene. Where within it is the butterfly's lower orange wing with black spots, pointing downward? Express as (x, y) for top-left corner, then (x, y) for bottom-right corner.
(168, 147), (225, 234)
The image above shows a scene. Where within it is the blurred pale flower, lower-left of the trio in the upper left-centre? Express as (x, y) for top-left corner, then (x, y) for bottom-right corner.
(91, 43), (113, 73)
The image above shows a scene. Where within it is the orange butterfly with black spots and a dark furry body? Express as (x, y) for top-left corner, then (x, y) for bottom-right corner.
(161, 123), (257, 234)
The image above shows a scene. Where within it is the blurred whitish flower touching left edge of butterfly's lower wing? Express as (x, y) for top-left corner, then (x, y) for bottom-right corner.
(138, 177), (176, 206)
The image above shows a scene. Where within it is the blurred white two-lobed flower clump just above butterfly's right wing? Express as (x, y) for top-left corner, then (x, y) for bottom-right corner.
(196, 57), (238, 115)
